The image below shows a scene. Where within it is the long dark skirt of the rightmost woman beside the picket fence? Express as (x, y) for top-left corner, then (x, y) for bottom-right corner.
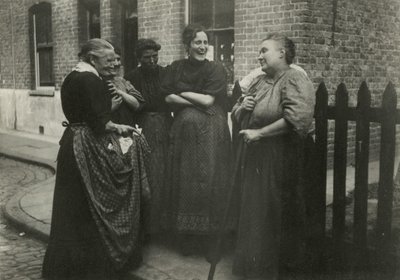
(233, 136), (305, 279)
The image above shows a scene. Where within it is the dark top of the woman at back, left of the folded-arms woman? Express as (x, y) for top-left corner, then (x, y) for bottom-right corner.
(125, 65), (168, 112)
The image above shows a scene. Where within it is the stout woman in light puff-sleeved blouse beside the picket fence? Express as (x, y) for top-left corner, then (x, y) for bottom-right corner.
(232, 34), (315, 279)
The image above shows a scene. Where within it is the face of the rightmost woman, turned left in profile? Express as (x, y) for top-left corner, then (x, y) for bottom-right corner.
(258, 40), (286, 74)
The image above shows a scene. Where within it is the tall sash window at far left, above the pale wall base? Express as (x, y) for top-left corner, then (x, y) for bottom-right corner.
(30, 2), (54, 88)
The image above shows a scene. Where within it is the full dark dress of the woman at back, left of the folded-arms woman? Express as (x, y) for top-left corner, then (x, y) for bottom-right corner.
(125, 65), (172, 234)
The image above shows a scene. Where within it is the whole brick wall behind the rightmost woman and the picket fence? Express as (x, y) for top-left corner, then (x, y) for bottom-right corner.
(235, 0), (400, 162)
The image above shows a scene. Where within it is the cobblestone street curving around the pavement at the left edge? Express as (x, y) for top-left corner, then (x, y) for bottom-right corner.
(0, 156), (53, 280)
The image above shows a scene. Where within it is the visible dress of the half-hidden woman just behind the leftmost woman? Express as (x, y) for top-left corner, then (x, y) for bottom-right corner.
(109, 76), (144, 126)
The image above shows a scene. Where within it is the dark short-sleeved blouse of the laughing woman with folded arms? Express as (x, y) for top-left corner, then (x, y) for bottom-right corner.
(161, 58), (228, 113)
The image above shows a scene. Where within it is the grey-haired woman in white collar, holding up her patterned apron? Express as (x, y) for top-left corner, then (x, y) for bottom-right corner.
(43, 39), (148, 280)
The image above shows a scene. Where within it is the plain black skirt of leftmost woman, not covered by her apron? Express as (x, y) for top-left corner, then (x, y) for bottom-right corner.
(42, 129), (135, 280)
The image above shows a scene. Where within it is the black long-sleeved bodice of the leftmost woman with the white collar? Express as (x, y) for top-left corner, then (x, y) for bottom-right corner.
(61, 71), (111, 133)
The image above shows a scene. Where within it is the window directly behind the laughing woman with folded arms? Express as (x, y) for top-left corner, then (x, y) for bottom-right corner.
(189, 0), (235, 82)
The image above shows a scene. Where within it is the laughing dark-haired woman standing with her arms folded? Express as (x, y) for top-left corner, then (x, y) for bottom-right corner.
(161, 26), (231, 254)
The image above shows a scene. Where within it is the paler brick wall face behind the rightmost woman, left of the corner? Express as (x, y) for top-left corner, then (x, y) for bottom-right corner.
(235, 0), (310, 79)
